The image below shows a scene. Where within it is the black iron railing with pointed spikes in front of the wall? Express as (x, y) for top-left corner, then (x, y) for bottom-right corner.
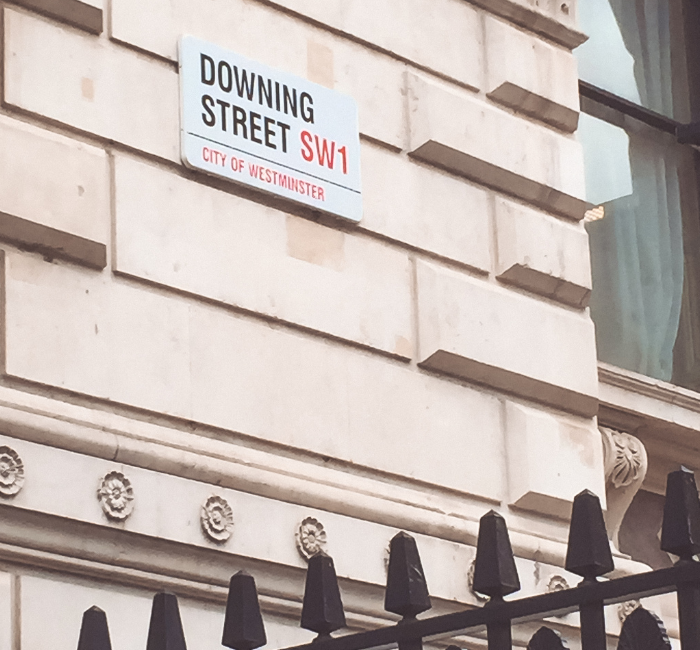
(78, 469), (700, 650)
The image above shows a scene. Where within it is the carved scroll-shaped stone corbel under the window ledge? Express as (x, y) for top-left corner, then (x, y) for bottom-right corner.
(599, 427), (648, 550)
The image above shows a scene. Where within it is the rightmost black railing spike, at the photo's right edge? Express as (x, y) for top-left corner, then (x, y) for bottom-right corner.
(661, 467), (700, 561)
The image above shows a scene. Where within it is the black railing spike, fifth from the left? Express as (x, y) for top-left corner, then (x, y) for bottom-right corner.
(384, 531), (432, 618)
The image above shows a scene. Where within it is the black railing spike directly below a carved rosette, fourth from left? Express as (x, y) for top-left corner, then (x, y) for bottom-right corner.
(301, 553), (345, 639)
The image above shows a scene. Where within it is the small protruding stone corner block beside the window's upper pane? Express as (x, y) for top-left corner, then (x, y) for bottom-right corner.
(484, 17), (579, 133)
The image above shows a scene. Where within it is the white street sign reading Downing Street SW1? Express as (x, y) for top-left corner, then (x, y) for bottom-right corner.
(180, 36), (362, 221)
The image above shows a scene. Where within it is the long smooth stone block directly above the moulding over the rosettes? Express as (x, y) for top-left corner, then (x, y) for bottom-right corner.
(5, 251), (505, 500)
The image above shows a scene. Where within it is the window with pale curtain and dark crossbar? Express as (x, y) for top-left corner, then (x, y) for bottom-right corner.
(575, 0), (700, 390)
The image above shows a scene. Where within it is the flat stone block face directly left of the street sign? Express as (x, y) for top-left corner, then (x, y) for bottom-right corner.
(4, 8), (180, 161)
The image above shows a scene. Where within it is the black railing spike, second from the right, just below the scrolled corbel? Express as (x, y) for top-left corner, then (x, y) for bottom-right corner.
(565, 490), (615, 580)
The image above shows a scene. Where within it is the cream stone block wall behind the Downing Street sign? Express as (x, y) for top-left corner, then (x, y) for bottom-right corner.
(0, 0), (624, 650)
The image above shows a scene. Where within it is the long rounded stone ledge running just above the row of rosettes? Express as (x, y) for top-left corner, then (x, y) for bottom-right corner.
(0, 386), (624, 573)
